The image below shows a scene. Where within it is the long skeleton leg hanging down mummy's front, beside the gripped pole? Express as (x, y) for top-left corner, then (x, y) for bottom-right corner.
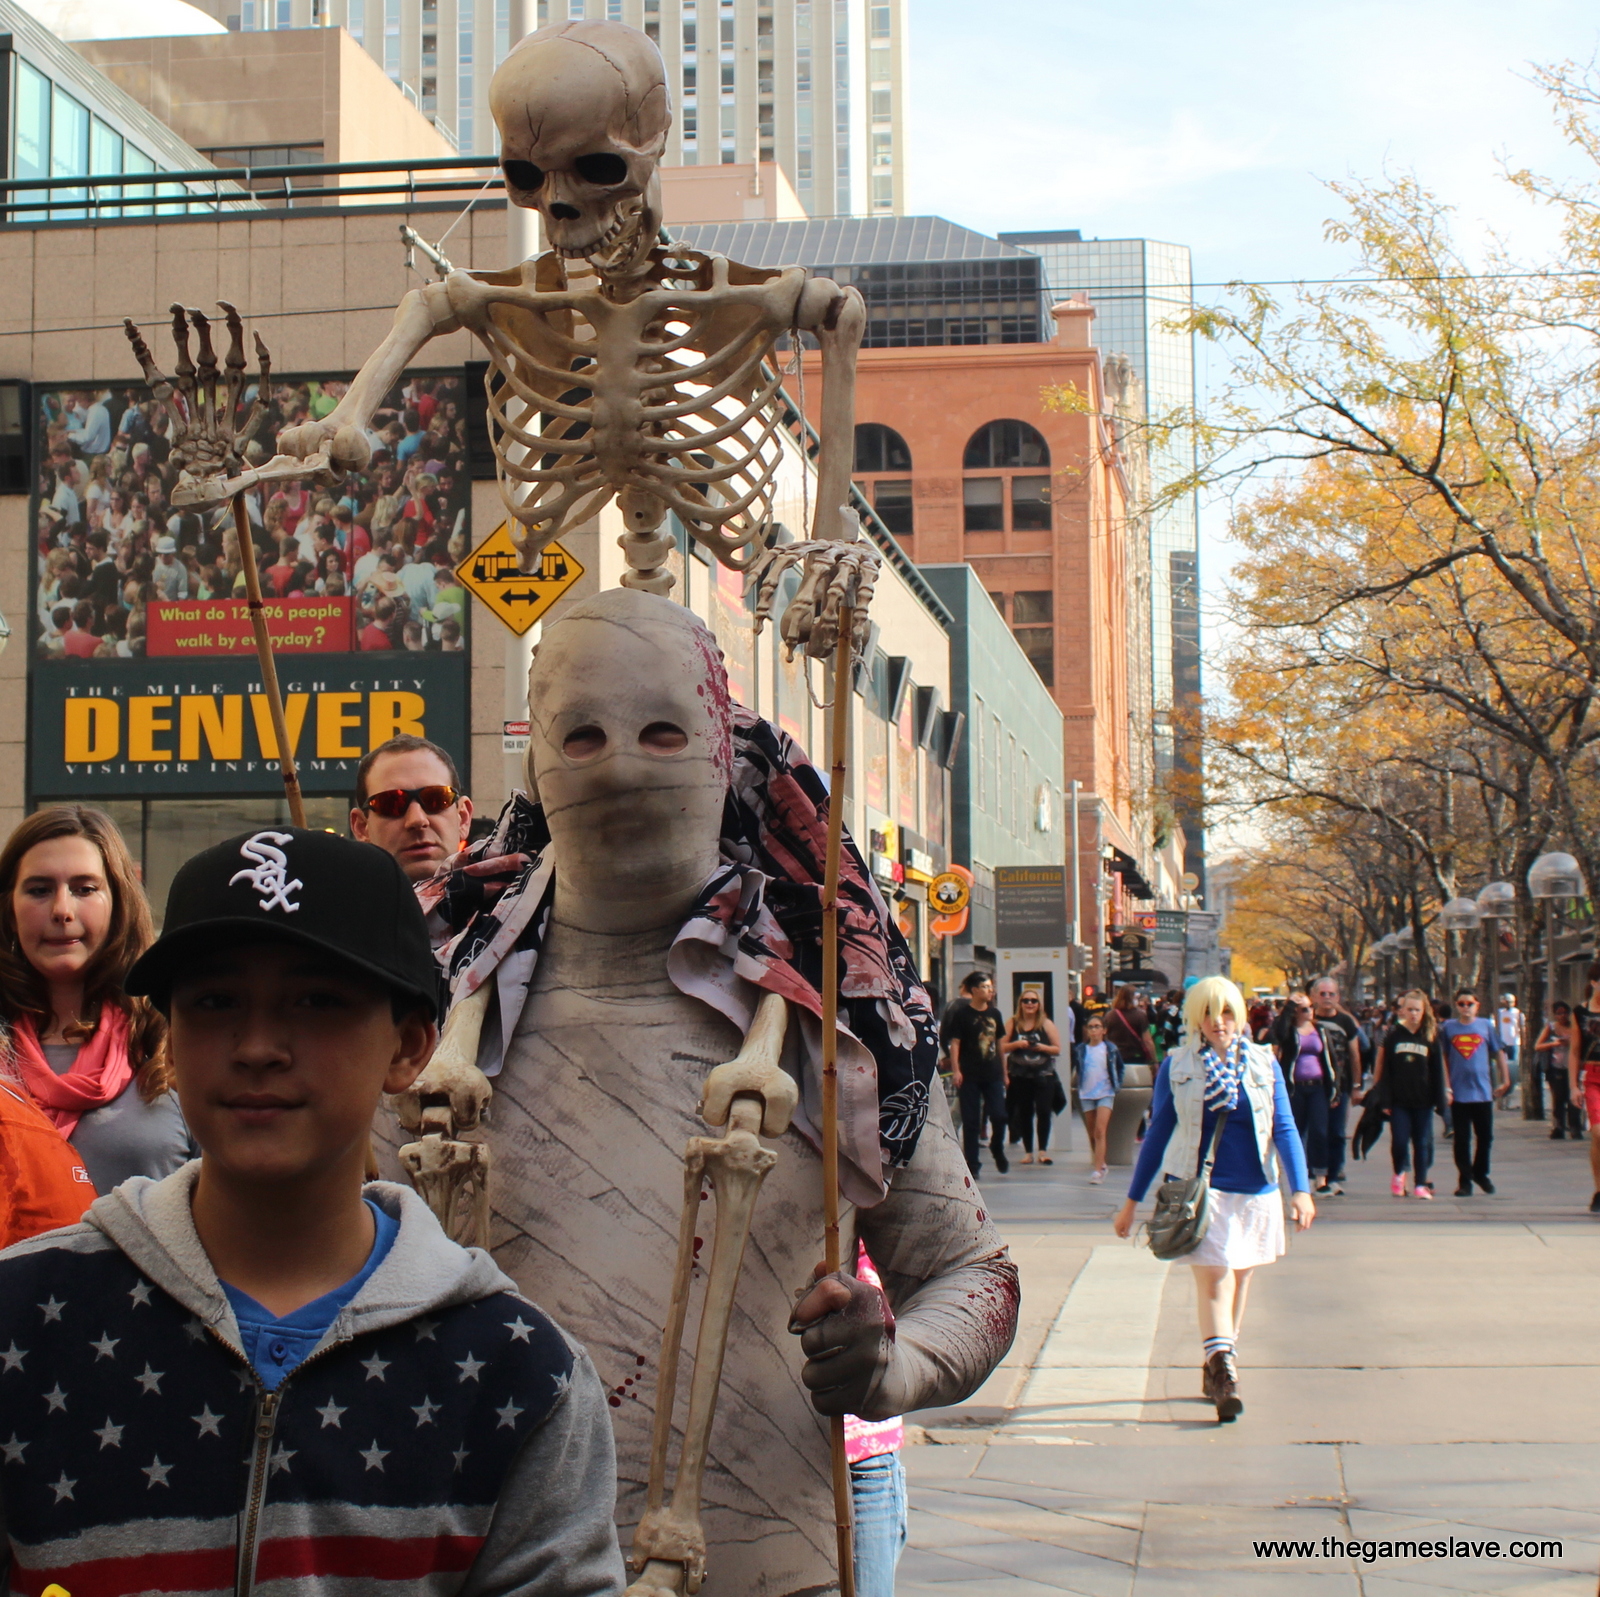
(626, 994), (798, 1597)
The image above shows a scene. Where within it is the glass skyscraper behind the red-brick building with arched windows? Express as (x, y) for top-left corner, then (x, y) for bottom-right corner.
(998, 229), (1205, 885)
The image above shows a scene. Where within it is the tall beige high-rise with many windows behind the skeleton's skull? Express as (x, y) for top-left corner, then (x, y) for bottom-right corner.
(200, 0), (909, 216)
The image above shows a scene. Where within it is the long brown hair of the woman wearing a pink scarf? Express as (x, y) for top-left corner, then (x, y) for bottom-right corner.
(0, 803), (173, 1103)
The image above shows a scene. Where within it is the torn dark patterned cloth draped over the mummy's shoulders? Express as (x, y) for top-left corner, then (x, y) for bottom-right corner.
(418, 706), (939, 1203)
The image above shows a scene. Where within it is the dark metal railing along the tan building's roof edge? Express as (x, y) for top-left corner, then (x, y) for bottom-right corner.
(0, 155), (499, 227)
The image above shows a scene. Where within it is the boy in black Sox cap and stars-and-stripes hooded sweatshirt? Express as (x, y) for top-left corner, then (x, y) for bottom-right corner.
(0, 827), (624, 1597)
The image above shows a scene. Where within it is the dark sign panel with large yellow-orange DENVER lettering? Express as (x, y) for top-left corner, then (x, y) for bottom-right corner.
(29, 653), (467, 799)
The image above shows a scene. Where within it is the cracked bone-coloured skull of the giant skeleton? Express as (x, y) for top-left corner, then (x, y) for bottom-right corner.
(490, 22), (672, 272)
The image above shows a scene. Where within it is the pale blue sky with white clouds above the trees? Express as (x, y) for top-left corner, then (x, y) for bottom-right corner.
(909, 0), (1600, 620)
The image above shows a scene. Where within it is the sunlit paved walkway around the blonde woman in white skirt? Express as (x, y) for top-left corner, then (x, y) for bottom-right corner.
(896, 1114), (1600, 1597)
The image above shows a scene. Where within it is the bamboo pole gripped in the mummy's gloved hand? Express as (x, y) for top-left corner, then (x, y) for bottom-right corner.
(822, 605), (856, 1597)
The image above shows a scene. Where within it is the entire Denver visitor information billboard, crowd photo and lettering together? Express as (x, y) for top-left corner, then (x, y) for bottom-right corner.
(27, 373), (472, 799)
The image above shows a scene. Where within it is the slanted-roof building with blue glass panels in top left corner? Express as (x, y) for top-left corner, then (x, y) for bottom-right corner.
(0, 0), (219, 221)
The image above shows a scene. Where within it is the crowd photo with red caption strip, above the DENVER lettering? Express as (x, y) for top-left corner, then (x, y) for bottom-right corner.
(29, 373), (472, 664)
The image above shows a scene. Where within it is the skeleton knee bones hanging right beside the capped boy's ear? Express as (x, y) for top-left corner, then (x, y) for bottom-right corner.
(394, 983), (494, 1248)
